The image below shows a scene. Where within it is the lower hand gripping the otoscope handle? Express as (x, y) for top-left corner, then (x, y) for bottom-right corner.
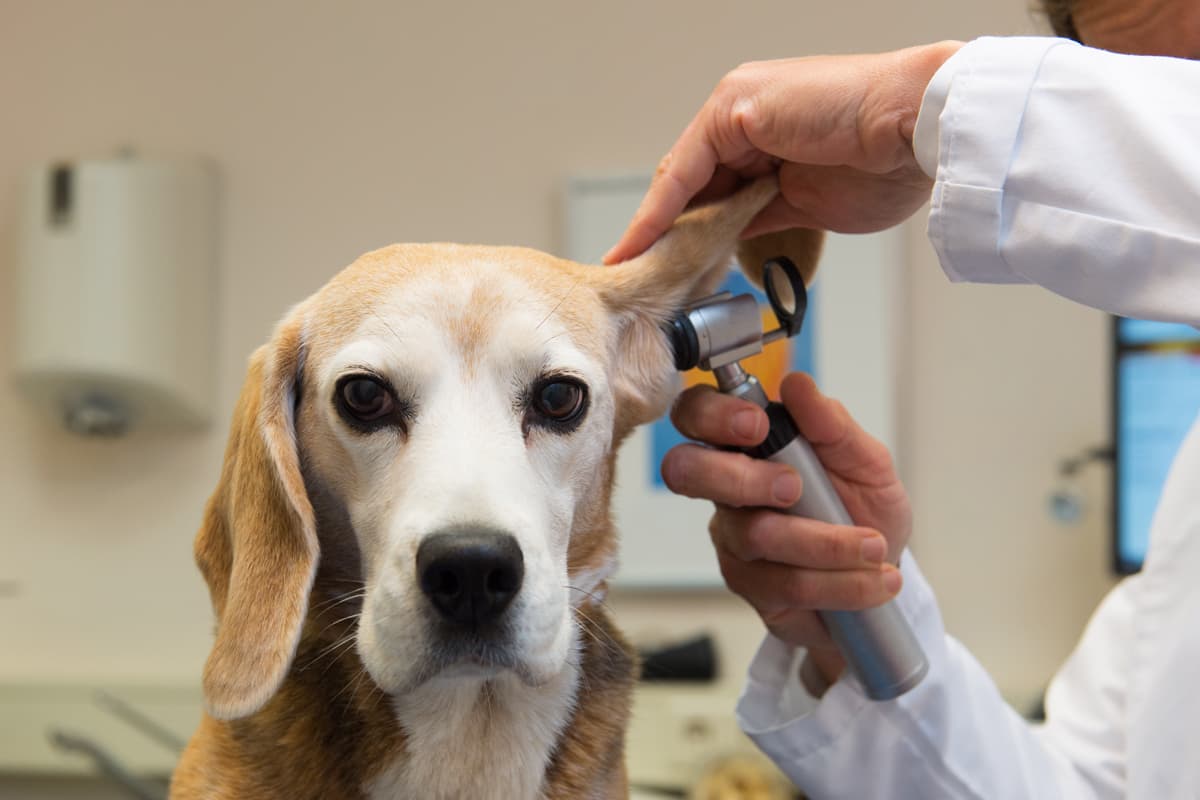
(662, 373), (912, 684)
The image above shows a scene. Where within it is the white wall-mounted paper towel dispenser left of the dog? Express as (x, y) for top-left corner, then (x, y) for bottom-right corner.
(14, 156), (216, 435)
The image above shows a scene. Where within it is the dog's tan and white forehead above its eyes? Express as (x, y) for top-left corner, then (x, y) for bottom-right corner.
(306, 245), (607, 366)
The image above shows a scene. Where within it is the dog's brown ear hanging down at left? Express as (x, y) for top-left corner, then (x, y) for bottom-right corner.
(196, 320), (317, 720)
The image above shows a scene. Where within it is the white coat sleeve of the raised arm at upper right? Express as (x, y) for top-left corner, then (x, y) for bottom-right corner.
(913, 37), (1200, 325)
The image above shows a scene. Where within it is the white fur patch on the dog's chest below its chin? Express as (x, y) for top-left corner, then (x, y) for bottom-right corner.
(366, 668), (577, 800)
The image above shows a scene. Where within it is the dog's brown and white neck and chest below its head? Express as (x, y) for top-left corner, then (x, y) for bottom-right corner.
(176, 603), (636, 800)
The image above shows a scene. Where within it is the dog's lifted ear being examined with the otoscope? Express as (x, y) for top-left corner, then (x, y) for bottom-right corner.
(598, 178), (822, 435)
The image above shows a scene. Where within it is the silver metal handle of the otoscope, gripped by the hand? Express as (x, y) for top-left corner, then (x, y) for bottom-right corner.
(746, 403), (929, 700)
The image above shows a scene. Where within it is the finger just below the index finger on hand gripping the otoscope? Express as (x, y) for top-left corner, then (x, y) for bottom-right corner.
(662, 444), (803, 509)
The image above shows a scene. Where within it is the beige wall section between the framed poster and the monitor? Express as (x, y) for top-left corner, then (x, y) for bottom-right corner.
(901, 241), (1114, 697)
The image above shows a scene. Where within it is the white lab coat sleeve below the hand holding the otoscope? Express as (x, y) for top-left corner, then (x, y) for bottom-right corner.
(738, 554), (1132, 800)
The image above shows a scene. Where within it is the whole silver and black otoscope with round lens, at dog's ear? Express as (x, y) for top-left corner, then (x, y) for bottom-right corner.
(665, 258), (929, 700)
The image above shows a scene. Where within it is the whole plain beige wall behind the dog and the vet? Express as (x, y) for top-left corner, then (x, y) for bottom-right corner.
(0, 0), (1106, 714)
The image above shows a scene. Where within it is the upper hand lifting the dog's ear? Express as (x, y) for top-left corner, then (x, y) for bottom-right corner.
(604, 42), (962, 264)
